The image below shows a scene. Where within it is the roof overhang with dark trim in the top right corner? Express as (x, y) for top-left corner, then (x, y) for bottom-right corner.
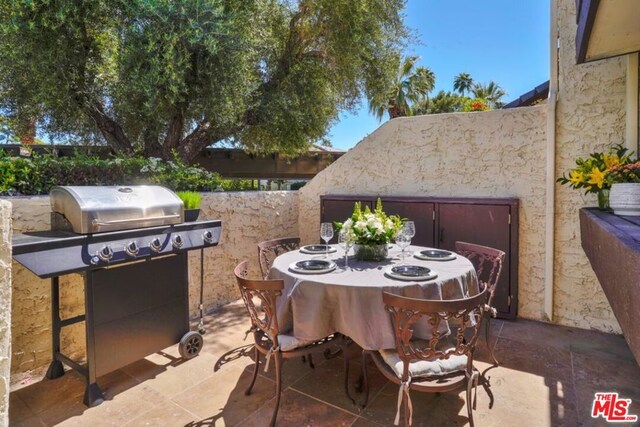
(576, 0), (640, 64)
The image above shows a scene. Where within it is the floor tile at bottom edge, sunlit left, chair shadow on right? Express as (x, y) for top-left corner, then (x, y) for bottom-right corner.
(172, 367), (275, 426)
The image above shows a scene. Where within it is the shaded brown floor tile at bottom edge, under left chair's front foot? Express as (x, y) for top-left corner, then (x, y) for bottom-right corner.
(240, 389), (356, 427)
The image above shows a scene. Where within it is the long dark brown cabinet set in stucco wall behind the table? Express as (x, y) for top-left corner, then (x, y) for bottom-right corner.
(320, 195), (518, 318)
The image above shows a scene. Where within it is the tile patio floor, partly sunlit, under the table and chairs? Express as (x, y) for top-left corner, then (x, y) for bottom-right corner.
(10, 304), (640, 427)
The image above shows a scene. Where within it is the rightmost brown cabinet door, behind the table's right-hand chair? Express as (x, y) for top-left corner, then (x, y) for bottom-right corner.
(437, 203), (512, 316)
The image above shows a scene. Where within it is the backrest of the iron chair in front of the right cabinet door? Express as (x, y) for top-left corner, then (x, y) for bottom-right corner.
(456, 242), (505, 305)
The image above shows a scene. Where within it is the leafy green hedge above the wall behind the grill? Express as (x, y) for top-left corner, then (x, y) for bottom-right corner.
(0, 151), (221, 196)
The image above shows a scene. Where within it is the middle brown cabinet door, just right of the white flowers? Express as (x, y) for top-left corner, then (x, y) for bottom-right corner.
(382, 199), (435, 247)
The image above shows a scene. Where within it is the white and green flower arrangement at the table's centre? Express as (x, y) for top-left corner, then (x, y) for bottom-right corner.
(335, 199), (402, 245)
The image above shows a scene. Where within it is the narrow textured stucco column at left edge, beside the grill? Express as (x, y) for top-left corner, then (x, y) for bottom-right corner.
(0, 200), (11, 426)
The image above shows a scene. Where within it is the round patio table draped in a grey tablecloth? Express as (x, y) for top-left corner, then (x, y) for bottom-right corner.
(269, 245), (478, 350)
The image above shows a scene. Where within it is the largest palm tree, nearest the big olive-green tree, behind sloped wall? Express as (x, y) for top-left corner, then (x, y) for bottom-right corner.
(369, 56), (436, 120)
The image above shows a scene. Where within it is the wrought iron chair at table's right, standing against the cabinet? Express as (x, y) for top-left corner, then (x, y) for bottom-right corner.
(456, 242), (505, 366)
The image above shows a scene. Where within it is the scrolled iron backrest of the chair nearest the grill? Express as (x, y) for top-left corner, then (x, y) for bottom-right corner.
(234, 261), (284, 347)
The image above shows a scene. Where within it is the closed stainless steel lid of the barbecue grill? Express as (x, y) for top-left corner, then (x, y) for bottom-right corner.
(49, 185), (184, 234)
